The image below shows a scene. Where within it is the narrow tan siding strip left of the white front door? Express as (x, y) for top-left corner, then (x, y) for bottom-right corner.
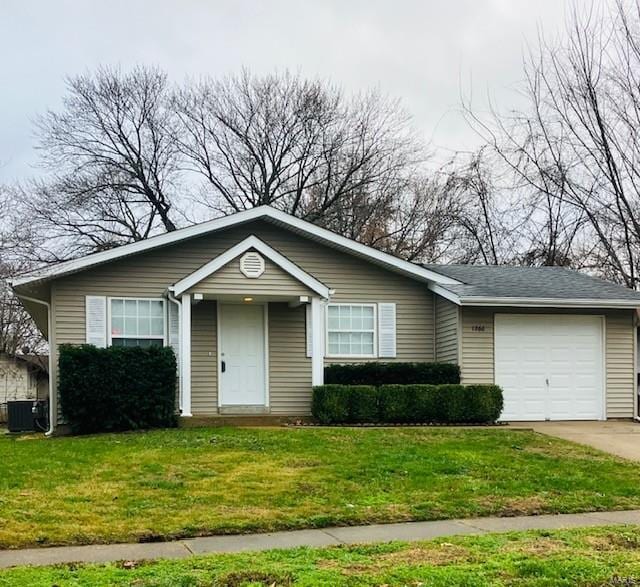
(191, 301), (218, 416)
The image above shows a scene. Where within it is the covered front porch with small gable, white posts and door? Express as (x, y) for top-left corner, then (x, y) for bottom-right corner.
(168, 237), (331, 417)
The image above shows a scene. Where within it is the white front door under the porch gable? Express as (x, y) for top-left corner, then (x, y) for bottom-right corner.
(218, 304), (266, 406)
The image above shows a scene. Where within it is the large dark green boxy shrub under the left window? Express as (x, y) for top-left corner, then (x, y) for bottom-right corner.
(59, 345), (177, 434)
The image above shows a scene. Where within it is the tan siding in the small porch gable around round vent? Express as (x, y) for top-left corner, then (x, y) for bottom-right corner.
(189, 257), (313, 297)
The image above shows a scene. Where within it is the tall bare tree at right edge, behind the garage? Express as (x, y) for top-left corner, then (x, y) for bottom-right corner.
(467, 0), (640, 287)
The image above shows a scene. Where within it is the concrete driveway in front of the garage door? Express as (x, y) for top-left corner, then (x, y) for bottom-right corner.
(526, 421), (640, 461)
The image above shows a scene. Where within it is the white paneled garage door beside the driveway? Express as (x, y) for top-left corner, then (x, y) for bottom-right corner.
(495, 314), (604, 421)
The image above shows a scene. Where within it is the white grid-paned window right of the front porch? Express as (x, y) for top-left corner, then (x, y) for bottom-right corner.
(327, 304), (376, 357)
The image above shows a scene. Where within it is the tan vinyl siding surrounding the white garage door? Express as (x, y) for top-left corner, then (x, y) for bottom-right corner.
(461, 307), (636, 418)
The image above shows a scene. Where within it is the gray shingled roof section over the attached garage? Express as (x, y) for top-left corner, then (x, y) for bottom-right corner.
(425, 265), (640, 308)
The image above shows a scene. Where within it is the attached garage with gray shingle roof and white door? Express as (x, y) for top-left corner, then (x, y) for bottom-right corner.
(428, 265), (640, 421)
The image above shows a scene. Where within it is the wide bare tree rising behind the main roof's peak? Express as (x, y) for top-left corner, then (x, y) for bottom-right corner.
(174, 72), (421, 226)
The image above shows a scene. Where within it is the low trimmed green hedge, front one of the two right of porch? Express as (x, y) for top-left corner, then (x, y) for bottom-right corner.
(312, 384), (503, 424)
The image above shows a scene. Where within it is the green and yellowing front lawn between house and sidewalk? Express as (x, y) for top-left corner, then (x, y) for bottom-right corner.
(0, 428), (640, 548)
